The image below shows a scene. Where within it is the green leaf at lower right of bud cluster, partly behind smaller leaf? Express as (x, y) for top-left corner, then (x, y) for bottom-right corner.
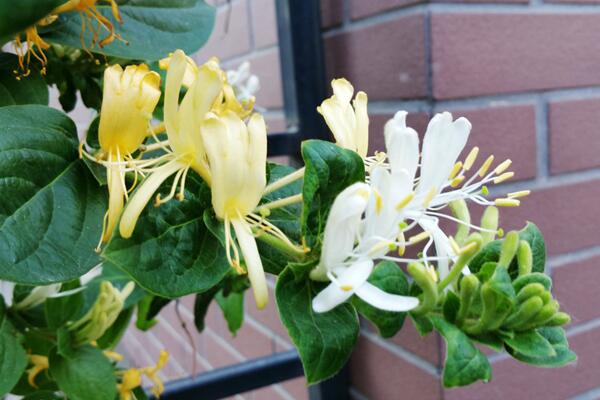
(508, 327), (577, 368)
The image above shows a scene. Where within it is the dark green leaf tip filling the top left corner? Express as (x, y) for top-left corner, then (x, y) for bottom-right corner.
(0, 0), (65, 41)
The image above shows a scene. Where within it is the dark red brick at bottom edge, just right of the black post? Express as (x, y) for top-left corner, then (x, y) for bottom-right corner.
(350, 337), (441, 400)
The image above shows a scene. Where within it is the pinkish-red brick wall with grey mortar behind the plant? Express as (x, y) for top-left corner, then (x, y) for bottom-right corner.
(54, 0), (600, 400)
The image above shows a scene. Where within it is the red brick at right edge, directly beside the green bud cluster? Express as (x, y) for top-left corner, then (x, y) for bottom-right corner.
(552, 257), (600, 323)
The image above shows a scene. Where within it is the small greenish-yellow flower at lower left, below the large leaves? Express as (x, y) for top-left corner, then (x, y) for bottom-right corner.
(69, 281), (135, 344)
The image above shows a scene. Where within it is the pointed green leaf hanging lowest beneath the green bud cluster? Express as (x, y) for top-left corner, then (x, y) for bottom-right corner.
(431, 317), (492, 388)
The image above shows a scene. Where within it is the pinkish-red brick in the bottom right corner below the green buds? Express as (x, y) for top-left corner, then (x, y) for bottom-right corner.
(444, 329), (600, 400)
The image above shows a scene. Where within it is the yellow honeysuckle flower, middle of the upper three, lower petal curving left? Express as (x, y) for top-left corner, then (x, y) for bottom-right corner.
(119, 50), (224, 238)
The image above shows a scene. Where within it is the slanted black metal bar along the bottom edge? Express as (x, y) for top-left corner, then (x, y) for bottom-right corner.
(155, 350), (304, 400)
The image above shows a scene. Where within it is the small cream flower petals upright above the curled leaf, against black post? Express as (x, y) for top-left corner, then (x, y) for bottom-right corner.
(317, 78), (369, 159)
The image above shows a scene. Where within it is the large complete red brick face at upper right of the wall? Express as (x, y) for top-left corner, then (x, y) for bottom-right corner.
(432, 13), (600, 99)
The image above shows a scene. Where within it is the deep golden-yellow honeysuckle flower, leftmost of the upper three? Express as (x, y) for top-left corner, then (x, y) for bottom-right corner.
(80, 64), (160, 247)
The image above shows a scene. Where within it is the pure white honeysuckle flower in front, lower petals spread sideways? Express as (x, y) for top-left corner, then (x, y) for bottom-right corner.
(311, 183), (419, 312)
